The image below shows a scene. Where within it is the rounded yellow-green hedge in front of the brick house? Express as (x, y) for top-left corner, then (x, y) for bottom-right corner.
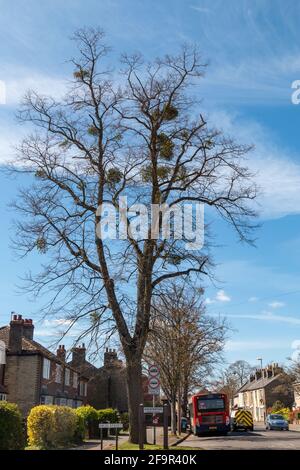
(27, 405), (78, 449)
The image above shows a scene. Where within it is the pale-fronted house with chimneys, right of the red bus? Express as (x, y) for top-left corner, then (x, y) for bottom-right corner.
(235, 363), (294, 421)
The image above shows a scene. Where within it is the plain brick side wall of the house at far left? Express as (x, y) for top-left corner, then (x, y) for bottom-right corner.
(5, 354), (41, 415)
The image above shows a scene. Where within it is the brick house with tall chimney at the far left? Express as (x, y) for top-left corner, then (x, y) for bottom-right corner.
(0, 314), (88, 416)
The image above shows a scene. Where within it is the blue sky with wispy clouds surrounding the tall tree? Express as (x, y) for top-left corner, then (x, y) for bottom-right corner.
(0, 0), (300, 363)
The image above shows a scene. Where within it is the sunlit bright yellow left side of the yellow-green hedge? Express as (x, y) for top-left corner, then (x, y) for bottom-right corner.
(27, 405), (55, 449)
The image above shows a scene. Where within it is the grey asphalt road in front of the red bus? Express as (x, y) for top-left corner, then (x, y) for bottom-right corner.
(178, 425), (300, 450)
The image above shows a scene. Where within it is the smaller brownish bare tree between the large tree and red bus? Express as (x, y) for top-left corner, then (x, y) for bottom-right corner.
(144, 282), (228, 434)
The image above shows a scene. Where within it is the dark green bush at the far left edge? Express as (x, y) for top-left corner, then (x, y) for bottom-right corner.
(0, 401), (25, 450)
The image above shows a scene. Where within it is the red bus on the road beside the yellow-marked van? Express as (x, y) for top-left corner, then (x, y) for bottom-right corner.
(189, 393), (230, 436)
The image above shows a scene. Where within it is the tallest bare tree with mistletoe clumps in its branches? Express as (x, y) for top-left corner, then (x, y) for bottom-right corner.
(6, 29), (256, 442)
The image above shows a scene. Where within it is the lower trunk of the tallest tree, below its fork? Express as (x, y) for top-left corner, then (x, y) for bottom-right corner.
(126, 352), (144, 444)
